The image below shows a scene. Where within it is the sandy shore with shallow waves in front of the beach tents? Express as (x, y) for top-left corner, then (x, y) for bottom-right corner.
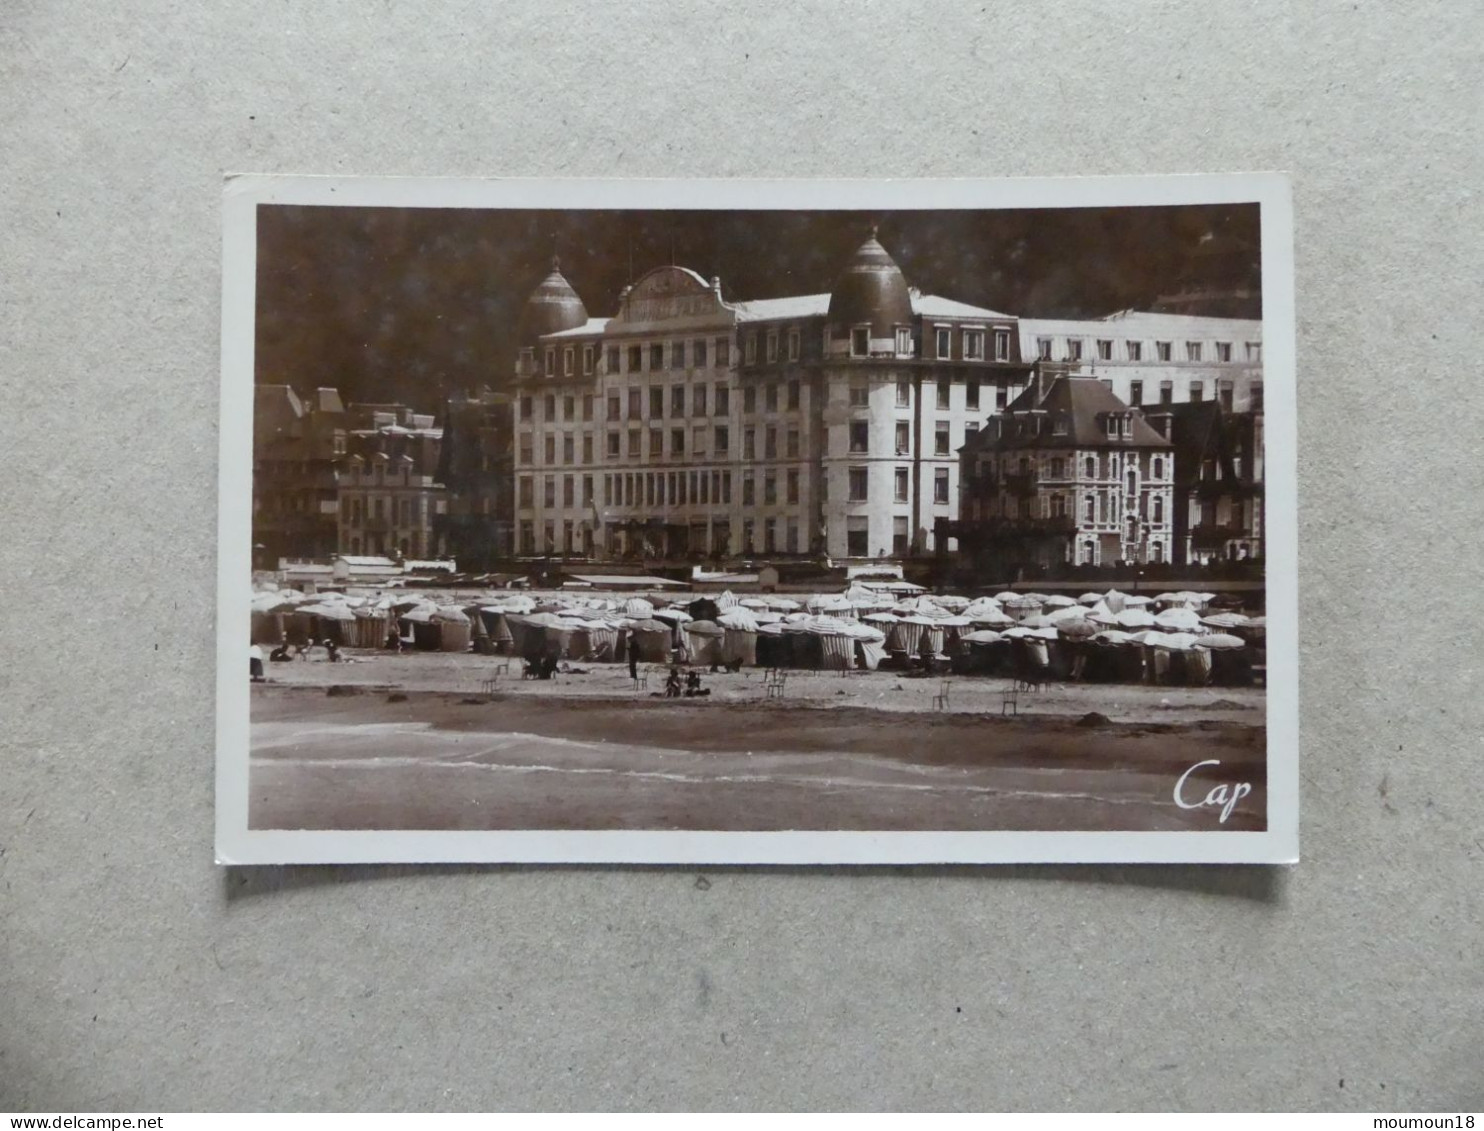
(249, 652), (1266, 831)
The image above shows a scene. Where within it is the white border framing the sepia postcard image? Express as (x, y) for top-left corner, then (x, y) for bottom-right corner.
(215, 174), (1299, 865)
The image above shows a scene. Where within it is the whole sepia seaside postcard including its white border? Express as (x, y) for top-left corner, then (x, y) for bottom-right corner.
(217, 174), (1299, 864)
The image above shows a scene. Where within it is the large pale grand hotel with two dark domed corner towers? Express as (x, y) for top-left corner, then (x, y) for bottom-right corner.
(512, 232), (1261, 558)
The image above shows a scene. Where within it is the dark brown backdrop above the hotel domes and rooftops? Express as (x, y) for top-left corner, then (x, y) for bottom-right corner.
(257, 205), (1260, 411)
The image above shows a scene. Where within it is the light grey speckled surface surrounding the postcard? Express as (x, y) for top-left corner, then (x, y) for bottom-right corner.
(0, 0), (1484, 1110)
